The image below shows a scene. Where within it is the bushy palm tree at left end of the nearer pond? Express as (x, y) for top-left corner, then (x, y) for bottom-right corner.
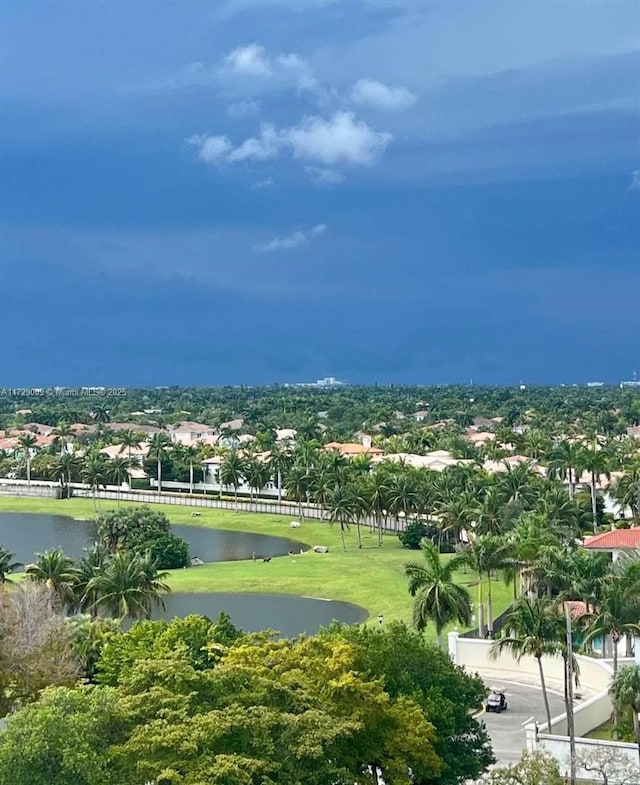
(85, 551), (170, 619)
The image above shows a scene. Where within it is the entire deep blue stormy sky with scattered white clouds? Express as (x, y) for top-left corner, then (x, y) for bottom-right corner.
(0, 0), (640, 387)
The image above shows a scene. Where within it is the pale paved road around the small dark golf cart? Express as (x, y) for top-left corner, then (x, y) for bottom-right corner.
(478, 682), (564, 764)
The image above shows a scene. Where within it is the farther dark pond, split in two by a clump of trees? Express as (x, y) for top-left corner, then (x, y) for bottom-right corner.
(0, 513), (308, 564)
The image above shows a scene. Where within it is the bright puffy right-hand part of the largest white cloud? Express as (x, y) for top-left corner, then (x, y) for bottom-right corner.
(286, 112), (393, 166)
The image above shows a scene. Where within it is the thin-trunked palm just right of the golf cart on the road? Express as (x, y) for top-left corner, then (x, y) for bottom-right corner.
(491, 597), (561, 729)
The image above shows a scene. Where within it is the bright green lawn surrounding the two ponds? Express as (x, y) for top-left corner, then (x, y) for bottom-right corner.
(0, 497), (510, 637)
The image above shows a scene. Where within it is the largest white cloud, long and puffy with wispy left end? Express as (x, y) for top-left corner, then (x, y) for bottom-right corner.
(187, 112), (393, 170)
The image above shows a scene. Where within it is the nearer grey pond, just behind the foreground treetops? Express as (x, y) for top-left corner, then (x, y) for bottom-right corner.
(154, 594), (368, 638)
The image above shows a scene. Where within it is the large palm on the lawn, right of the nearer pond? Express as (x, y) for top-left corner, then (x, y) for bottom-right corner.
(404, 541), (471, 647)
